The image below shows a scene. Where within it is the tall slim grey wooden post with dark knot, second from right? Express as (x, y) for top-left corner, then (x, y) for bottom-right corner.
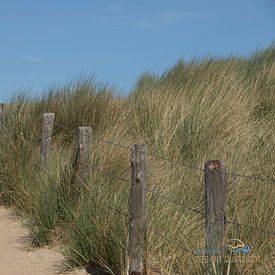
(128, 144), (147, 275)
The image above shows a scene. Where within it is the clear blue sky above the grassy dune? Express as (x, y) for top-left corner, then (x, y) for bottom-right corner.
(0, 0), (275, 101)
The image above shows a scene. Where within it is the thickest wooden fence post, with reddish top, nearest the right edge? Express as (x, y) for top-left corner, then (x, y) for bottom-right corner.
(204, 160), (227, 274)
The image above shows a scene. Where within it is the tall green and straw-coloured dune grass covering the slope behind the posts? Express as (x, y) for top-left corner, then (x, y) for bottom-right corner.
(0, 47), (275, 274)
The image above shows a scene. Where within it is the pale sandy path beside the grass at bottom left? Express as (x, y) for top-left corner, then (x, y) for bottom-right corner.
(0, 206), (88, 275)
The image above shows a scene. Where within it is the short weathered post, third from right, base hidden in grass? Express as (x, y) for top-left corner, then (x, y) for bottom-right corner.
(73, 127), (92, 185)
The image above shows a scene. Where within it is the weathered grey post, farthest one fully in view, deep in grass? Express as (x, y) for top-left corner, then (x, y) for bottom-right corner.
(41, 113), (54, 166)
